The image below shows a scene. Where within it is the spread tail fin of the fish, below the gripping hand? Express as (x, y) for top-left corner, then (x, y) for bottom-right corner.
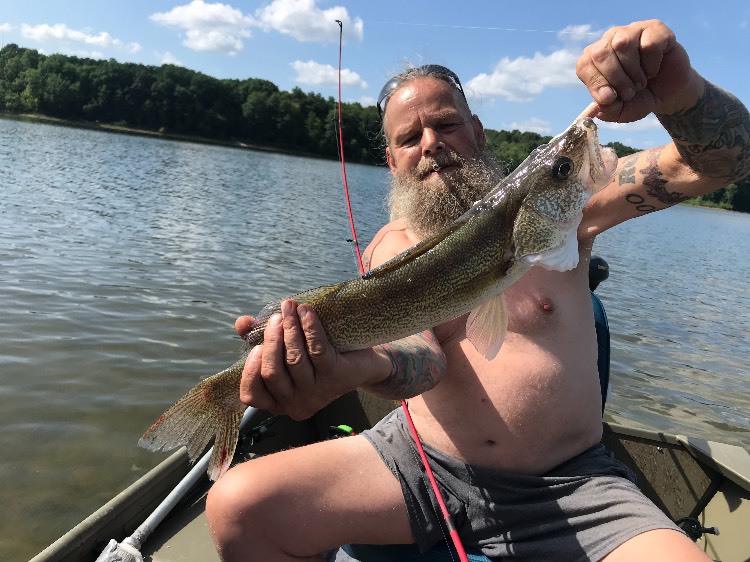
(138, 361), (245, 480)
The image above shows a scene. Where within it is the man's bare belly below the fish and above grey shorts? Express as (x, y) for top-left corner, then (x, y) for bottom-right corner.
(409, 332), (602, 474)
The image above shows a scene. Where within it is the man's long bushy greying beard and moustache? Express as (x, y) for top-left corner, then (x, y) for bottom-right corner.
(388, 149), (503, 238)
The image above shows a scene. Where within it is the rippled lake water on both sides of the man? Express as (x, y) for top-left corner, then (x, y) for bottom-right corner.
(0, 119), (750, 560)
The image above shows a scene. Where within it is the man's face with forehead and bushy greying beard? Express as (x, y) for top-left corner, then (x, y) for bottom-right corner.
(383, 78), (502, 237)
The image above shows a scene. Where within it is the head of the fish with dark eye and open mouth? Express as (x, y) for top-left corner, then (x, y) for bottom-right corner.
(509, 117), (617, 271)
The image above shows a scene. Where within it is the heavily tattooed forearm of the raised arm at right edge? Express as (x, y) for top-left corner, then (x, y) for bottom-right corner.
(657, 82), (750, 181)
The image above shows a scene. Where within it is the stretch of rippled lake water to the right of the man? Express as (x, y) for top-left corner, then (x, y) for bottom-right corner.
(595, 206), (750, 440)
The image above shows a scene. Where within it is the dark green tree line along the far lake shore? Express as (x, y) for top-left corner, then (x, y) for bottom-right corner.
(0, 44), (750, 212)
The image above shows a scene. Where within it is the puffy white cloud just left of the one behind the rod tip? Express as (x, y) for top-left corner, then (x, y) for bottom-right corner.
(149, 0), (256, 55)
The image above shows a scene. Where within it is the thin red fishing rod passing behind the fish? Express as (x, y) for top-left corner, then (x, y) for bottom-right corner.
(336, 20), (469, 562)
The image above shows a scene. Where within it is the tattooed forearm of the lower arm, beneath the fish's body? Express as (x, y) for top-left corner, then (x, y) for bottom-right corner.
(365, 330), (446, 399)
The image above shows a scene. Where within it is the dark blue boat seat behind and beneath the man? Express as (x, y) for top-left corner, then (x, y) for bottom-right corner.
(334, 257), (610, 562)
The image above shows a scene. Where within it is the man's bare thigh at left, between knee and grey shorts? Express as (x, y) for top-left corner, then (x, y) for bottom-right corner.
(209, 436), (413, 556)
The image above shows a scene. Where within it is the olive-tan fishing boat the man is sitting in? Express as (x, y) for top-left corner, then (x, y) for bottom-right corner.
(32, 384), (750, 562)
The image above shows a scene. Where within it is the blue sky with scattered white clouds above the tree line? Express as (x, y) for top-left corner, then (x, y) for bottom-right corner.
(0, 0), (750, 148)
